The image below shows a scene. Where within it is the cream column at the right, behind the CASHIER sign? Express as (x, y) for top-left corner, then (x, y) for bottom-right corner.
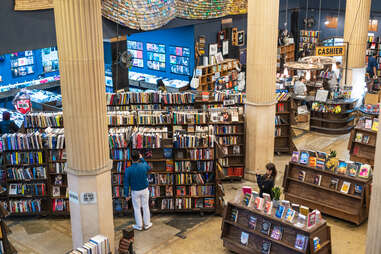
(342, 0), (371, 102)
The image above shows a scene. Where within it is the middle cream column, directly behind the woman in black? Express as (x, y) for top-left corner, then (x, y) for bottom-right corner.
(245, 0), (279, 180)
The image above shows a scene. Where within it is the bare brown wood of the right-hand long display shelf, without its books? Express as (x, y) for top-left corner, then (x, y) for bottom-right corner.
(283, 162), (372, 225)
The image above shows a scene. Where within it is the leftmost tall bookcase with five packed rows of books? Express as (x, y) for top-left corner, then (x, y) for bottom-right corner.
(1, 132), (49, 216)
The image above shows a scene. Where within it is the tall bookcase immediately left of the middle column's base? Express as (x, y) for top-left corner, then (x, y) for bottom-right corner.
(210, 108), (246, 180)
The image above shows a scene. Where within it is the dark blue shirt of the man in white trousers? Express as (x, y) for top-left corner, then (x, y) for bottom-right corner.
(123, 158), (151, 197)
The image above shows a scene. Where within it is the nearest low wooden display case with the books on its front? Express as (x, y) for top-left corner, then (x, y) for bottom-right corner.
(221, 201), (332, 254)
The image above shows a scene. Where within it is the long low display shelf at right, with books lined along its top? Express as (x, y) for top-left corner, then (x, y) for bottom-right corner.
(283, 151), (372, 225)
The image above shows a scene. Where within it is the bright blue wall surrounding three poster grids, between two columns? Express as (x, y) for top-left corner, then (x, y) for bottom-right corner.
(127, 26), (194, 81)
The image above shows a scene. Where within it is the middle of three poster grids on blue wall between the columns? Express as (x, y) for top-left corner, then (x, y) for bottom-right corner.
(146, 43), (166, 72)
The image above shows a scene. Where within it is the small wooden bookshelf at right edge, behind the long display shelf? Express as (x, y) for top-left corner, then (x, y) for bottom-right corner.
(348, 127), (377, 166)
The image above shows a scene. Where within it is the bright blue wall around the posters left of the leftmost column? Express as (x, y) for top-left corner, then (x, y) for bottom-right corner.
(0, 49), (59, 86)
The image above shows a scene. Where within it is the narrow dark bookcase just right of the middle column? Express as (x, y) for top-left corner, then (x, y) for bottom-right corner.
(274, 91), (294, 153)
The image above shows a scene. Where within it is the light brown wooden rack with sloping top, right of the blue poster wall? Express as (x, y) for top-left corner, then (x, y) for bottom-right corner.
(197, 59), (239, 91)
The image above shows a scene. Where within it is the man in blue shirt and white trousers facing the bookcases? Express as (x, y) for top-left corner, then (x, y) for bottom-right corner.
(124, 151), (152, 230)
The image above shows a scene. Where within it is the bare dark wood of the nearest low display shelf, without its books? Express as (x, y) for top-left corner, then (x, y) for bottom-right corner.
(221, 202), (332, 254)
